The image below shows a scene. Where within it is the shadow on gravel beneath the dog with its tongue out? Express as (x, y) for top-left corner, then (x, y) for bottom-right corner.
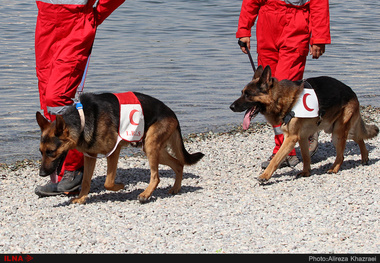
(260, 141), (380, 186)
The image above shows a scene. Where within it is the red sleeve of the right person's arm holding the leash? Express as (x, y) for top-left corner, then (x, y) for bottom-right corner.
(236, 0), (263, 38)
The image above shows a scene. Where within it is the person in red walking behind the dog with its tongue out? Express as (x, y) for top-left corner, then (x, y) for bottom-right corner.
(236, 0), (331, 168)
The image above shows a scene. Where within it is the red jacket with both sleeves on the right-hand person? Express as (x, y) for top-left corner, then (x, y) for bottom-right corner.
(236, 0), (331, 45)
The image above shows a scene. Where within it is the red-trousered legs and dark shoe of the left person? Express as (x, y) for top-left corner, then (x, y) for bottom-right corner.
(35, 2), (95, 196)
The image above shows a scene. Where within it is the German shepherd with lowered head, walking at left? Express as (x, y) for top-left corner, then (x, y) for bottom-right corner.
(36, 92), (204, 204)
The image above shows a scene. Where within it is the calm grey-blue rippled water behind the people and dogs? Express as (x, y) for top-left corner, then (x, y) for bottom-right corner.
(0, 0), (380, 162)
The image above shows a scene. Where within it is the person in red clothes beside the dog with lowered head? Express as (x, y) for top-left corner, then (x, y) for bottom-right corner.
(35, 0), (125, 196)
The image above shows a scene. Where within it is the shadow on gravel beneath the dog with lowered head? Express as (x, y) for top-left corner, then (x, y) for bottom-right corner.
(56, 168), (202, 206)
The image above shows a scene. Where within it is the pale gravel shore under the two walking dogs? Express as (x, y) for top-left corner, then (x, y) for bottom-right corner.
(0, 107), (380, 253)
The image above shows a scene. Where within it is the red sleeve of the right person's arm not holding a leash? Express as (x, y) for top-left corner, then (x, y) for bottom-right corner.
(310, 0), (331, 45)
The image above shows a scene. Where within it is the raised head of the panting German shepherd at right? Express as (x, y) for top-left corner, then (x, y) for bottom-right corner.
(230, 66), (274, 128)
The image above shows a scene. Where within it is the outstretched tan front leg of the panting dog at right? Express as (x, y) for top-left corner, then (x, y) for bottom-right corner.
(257, 135), (298, 182)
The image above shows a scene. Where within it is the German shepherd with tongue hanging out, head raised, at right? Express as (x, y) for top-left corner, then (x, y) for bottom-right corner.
(230, 66), (379, 182)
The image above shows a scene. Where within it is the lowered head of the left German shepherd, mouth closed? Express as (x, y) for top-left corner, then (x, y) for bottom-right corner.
(36, 112), (73, 182)
